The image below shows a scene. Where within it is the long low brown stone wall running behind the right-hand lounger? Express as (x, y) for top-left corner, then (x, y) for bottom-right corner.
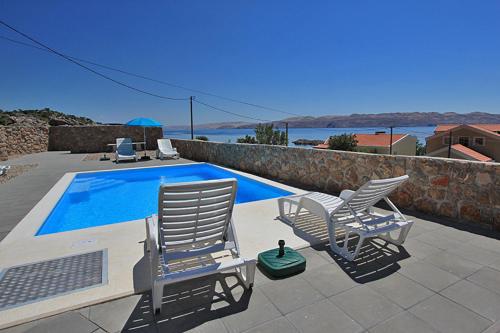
(172, 139), (500, 231)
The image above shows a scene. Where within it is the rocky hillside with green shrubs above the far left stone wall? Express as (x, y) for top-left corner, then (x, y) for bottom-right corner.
(0, 108), (97, 126)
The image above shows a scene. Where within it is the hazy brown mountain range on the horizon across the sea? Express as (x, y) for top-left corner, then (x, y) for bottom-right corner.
(170, 112), (500, 129)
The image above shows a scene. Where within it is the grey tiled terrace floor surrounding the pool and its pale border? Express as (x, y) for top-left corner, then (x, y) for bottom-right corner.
(0, 152), (500, 333)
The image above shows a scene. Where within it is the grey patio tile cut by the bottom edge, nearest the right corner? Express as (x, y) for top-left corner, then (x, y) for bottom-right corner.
(409, 295), (493, 333)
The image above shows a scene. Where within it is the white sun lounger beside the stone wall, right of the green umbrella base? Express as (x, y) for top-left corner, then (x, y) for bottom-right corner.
(278, 175), (413, 261)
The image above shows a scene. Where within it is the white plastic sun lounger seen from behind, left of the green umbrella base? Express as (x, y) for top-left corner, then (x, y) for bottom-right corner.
(146, 179), (256, 312)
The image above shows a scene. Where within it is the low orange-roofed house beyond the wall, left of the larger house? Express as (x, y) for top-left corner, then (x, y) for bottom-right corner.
(313, 132), (417, 156)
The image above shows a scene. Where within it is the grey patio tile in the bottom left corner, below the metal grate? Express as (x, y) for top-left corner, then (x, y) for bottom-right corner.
(0, 311), (99, 333)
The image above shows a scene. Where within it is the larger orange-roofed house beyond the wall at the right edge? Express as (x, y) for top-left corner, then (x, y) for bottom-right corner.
(426, 124), (500, 162)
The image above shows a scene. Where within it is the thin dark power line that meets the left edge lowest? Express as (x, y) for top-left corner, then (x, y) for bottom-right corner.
(0, 36), (303, 117)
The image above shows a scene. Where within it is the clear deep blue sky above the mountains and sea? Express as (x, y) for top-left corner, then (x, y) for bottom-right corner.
(0, 0), (500, 125)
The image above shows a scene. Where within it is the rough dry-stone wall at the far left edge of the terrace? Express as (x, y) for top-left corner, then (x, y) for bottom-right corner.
(0, 126), (49, 161)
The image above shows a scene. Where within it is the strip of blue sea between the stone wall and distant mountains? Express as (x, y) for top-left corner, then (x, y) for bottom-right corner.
(163, 126), (436, 147)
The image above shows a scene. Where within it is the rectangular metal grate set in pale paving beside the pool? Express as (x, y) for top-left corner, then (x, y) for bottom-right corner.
(0, 249), (107, 311)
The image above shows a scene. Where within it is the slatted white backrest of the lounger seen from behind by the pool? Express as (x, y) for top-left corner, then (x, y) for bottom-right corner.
(158, 178), (237, 248)
